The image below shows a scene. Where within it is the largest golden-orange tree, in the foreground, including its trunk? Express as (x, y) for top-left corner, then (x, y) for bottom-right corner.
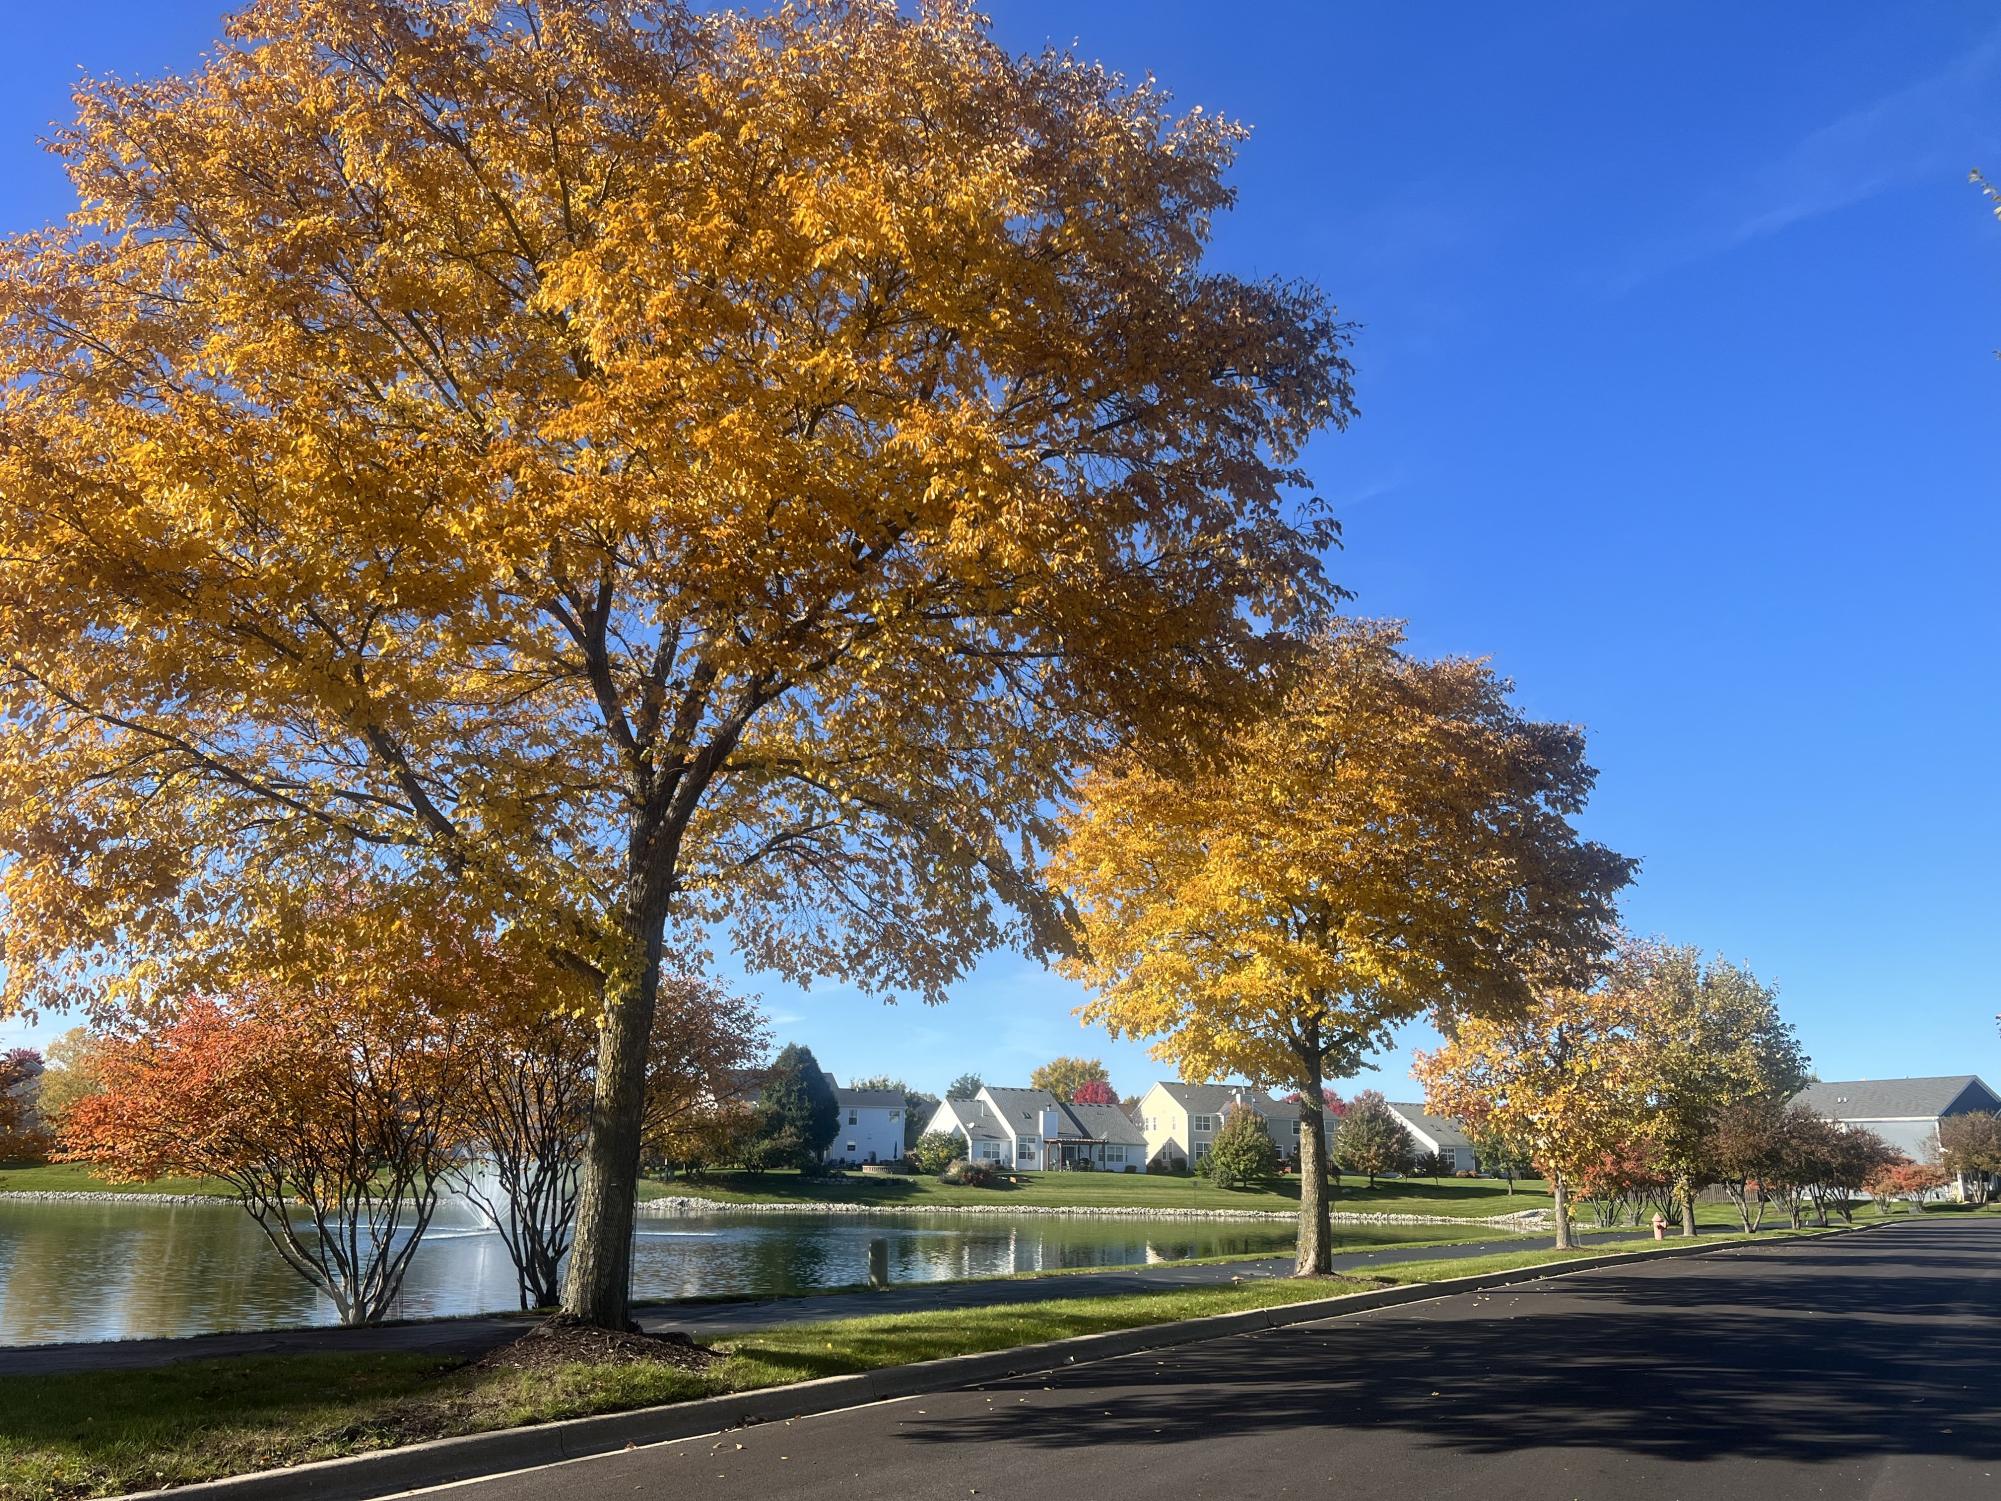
(0, 0), (1351, 1325)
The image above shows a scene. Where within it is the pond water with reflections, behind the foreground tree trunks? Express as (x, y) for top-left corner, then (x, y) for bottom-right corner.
(0, 1195), (1293, 1345)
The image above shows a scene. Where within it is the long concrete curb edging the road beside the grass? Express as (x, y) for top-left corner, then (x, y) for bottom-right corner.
(126, 1221), (1872, 1501)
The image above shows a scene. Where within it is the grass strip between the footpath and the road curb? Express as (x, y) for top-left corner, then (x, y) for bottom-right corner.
(0, 1231), (1856, 1501)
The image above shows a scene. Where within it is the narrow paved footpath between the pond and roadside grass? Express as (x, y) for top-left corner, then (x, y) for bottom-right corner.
(0, 1227), (1664, 1377)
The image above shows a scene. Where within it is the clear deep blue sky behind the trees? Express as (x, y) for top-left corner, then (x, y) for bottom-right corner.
(0, 0), (2001, 1097)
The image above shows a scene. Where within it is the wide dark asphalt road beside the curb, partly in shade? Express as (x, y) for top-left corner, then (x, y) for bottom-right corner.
(436, 1219), (2001, 1501)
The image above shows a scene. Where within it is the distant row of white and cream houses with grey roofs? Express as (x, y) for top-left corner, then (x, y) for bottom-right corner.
(826, 1075), (2001, 1200)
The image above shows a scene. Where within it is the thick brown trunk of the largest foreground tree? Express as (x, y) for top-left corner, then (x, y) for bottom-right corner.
(562, 928), (666, 1329)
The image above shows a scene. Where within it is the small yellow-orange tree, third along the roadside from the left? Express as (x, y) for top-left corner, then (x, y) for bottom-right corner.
(1415, 989), (1647, 1249)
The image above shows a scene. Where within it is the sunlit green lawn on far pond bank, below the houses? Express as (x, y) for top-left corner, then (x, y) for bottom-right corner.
(640, 1173), (1549, 1219)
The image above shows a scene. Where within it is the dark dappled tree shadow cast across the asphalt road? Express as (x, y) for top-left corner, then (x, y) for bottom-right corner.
(906, 1235), (2001, 1463)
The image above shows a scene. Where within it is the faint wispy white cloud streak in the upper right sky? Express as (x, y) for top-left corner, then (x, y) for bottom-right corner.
(1609, 30), (2001, 294)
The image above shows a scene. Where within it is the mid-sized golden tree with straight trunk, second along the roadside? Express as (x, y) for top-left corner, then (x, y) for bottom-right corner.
(1053, 622), (1633, 1275)
